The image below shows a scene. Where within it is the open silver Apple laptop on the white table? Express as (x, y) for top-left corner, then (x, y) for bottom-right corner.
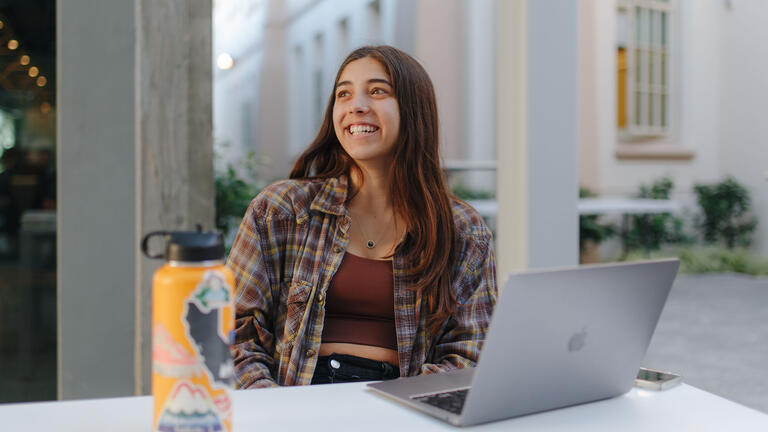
(368, 259), (680, 426)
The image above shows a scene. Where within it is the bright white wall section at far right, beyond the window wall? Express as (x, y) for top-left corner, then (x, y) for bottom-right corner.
(717, 0), (768, 256)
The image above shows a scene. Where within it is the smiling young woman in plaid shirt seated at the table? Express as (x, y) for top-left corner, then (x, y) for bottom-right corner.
(228, 46), (497, 388)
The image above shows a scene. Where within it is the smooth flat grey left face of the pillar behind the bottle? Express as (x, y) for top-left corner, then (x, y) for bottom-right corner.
(56, 0), (138, 399)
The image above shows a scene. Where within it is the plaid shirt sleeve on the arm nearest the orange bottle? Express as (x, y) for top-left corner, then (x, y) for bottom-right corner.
(227, 198), (278, 388)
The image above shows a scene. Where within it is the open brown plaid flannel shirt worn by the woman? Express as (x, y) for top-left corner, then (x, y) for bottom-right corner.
(227, 177), (497, 388)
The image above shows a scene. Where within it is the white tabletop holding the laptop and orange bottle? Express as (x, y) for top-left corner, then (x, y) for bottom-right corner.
(0, 383), (768, 432)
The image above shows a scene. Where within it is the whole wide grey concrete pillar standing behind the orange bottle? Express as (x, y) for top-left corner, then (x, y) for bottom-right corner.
(56, 0), (213, 399)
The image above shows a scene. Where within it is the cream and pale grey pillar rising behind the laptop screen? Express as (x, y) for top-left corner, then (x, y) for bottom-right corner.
(496, 0), (579, 283)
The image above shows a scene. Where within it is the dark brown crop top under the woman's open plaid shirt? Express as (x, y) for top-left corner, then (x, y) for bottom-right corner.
(322, 252), (397, 350)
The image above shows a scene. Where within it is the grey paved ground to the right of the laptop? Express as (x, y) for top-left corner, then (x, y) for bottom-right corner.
(644, 274), (768, 413)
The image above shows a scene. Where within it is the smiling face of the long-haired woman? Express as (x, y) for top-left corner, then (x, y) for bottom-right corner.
(333, 57), (400, 165)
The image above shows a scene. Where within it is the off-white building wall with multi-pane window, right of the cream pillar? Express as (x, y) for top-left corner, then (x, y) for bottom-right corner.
(579, 0), (768, 256)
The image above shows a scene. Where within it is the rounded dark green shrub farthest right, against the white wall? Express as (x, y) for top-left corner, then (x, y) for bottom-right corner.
(693, 177), (757, 249)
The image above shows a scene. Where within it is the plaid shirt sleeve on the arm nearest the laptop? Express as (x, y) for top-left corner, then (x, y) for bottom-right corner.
(420, 236), (498, 375)
